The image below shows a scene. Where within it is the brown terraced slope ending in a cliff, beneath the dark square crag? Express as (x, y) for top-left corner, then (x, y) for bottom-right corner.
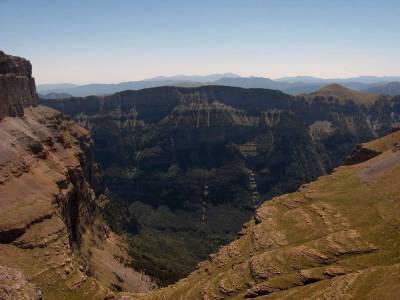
(0, 106), (104, 299)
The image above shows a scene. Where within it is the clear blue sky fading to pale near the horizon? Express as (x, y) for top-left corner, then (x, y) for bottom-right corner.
(0, 0), (400, 83)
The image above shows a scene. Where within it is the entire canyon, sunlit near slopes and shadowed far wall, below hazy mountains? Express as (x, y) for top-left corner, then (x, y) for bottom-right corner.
(0, 52), (400, 299)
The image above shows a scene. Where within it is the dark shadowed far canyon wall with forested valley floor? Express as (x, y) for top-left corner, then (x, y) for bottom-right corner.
(42, 86), (400, 283)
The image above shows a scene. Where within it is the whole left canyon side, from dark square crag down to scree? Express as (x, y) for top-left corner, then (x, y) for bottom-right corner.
(0, 51), (154, 299)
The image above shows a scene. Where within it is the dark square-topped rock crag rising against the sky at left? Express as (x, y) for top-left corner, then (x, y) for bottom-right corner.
(0, 51), (38, 119)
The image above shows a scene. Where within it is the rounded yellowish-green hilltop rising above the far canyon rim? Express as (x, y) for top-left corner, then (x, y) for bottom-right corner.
(310, 84), (379, 105)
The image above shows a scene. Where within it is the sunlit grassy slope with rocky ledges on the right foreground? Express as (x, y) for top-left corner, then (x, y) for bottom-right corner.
(130, 127), (400, 299)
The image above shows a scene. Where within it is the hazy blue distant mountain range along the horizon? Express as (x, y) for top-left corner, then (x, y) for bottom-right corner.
(37, 73), (400, 99)
